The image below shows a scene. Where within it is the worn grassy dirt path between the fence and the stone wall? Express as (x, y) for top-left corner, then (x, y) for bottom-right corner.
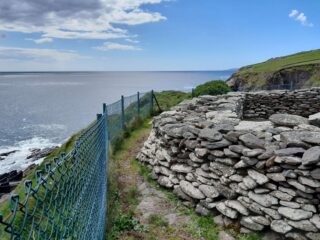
(108, 122), (257, 240)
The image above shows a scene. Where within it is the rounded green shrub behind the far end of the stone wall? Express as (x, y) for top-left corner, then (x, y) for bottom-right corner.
(194, 80), (230, 97)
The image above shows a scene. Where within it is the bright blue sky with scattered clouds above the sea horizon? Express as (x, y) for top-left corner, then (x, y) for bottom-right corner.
(0, 0), (320, 71)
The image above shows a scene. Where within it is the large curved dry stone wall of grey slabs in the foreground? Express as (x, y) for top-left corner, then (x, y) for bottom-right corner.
(137, 93), (320, 240)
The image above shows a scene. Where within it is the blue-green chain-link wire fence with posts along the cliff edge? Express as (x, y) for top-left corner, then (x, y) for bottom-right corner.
(0, 91), (158, 240)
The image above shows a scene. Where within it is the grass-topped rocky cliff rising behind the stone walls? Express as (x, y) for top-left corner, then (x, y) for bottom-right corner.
(227, 50), (320, 91)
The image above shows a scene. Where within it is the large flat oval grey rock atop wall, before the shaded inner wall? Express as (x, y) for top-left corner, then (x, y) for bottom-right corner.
(269, 113), (309, 127)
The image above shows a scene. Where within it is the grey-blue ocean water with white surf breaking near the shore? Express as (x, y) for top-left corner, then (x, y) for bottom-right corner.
(0, 70), (233, 174)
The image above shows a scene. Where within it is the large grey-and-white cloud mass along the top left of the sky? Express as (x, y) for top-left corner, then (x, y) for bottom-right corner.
(0, 0), (166, 40)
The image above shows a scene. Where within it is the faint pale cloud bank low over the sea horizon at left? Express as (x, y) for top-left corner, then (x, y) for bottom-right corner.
(0, 46), (84, 62)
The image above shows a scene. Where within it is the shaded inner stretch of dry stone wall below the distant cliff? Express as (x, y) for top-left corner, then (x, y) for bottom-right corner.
(244, 88), (320, 119)
